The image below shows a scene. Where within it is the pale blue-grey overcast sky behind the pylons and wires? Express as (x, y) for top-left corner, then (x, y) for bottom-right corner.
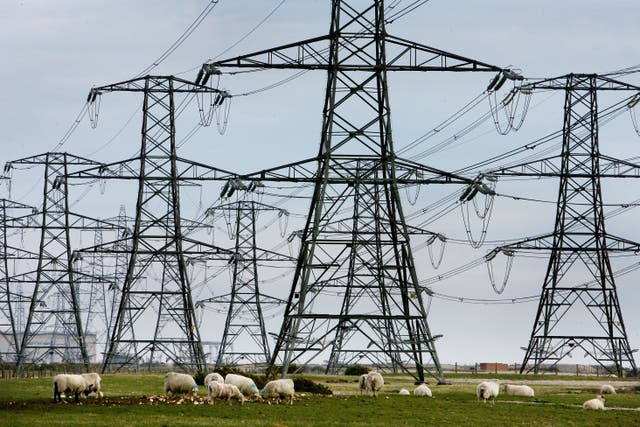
(0, 0), (640, 363)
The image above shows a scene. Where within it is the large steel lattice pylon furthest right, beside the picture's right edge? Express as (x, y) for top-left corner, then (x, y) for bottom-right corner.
(490, 74), (640, 376)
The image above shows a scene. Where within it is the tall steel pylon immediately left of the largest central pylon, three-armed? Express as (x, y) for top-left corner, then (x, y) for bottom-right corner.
(68, 76), (236, 371)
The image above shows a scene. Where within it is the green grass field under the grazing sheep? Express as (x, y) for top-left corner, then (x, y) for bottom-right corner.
(0, 374), (640, 427)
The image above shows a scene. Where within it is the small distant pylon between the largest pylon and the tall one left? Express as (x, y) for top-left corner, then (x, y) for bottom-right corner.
(198, 195), (295, 368)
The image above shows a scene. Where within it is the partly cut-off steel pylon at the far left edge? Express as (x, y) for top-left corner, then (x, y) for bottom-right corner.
(0, 199), (38, 363)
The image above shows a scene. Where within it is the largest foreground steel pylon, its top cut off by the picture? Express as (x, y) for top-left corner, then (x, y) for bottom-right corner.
(196, 0), (519, 382)
